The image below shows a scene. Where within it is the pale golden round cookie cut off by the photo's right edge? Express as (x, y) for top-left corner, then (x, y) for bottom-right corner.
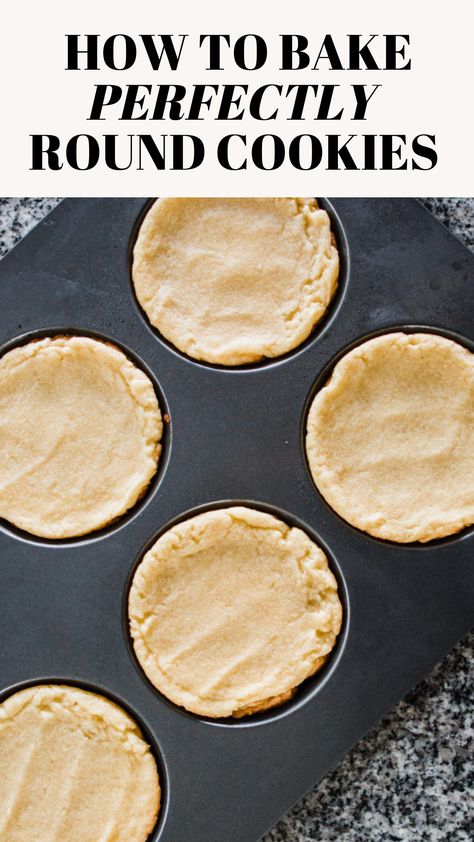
(306, 333), (474, 543)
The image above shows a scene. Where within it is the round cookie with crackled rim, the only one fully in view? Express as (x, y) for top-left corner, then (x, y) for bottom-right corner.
(129, 506), (342, 717)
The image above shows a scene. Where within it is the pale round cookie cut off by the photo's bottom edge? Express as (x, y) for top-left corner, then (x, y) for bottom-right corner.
(0, 685), (160, 842)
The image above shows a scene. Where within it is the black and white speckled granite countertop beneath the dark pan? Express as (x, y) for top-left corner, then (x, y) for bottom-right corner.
(0, 198), (474, 842)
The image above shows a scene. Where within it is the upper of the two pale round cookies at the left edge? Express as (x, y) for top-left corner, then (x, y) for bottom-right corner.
(0, 336), (162, 538)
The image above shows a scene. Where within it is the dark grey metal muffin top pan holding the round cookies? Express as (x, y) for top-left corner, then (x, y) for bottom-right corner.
(0, 199), (474, 842)
